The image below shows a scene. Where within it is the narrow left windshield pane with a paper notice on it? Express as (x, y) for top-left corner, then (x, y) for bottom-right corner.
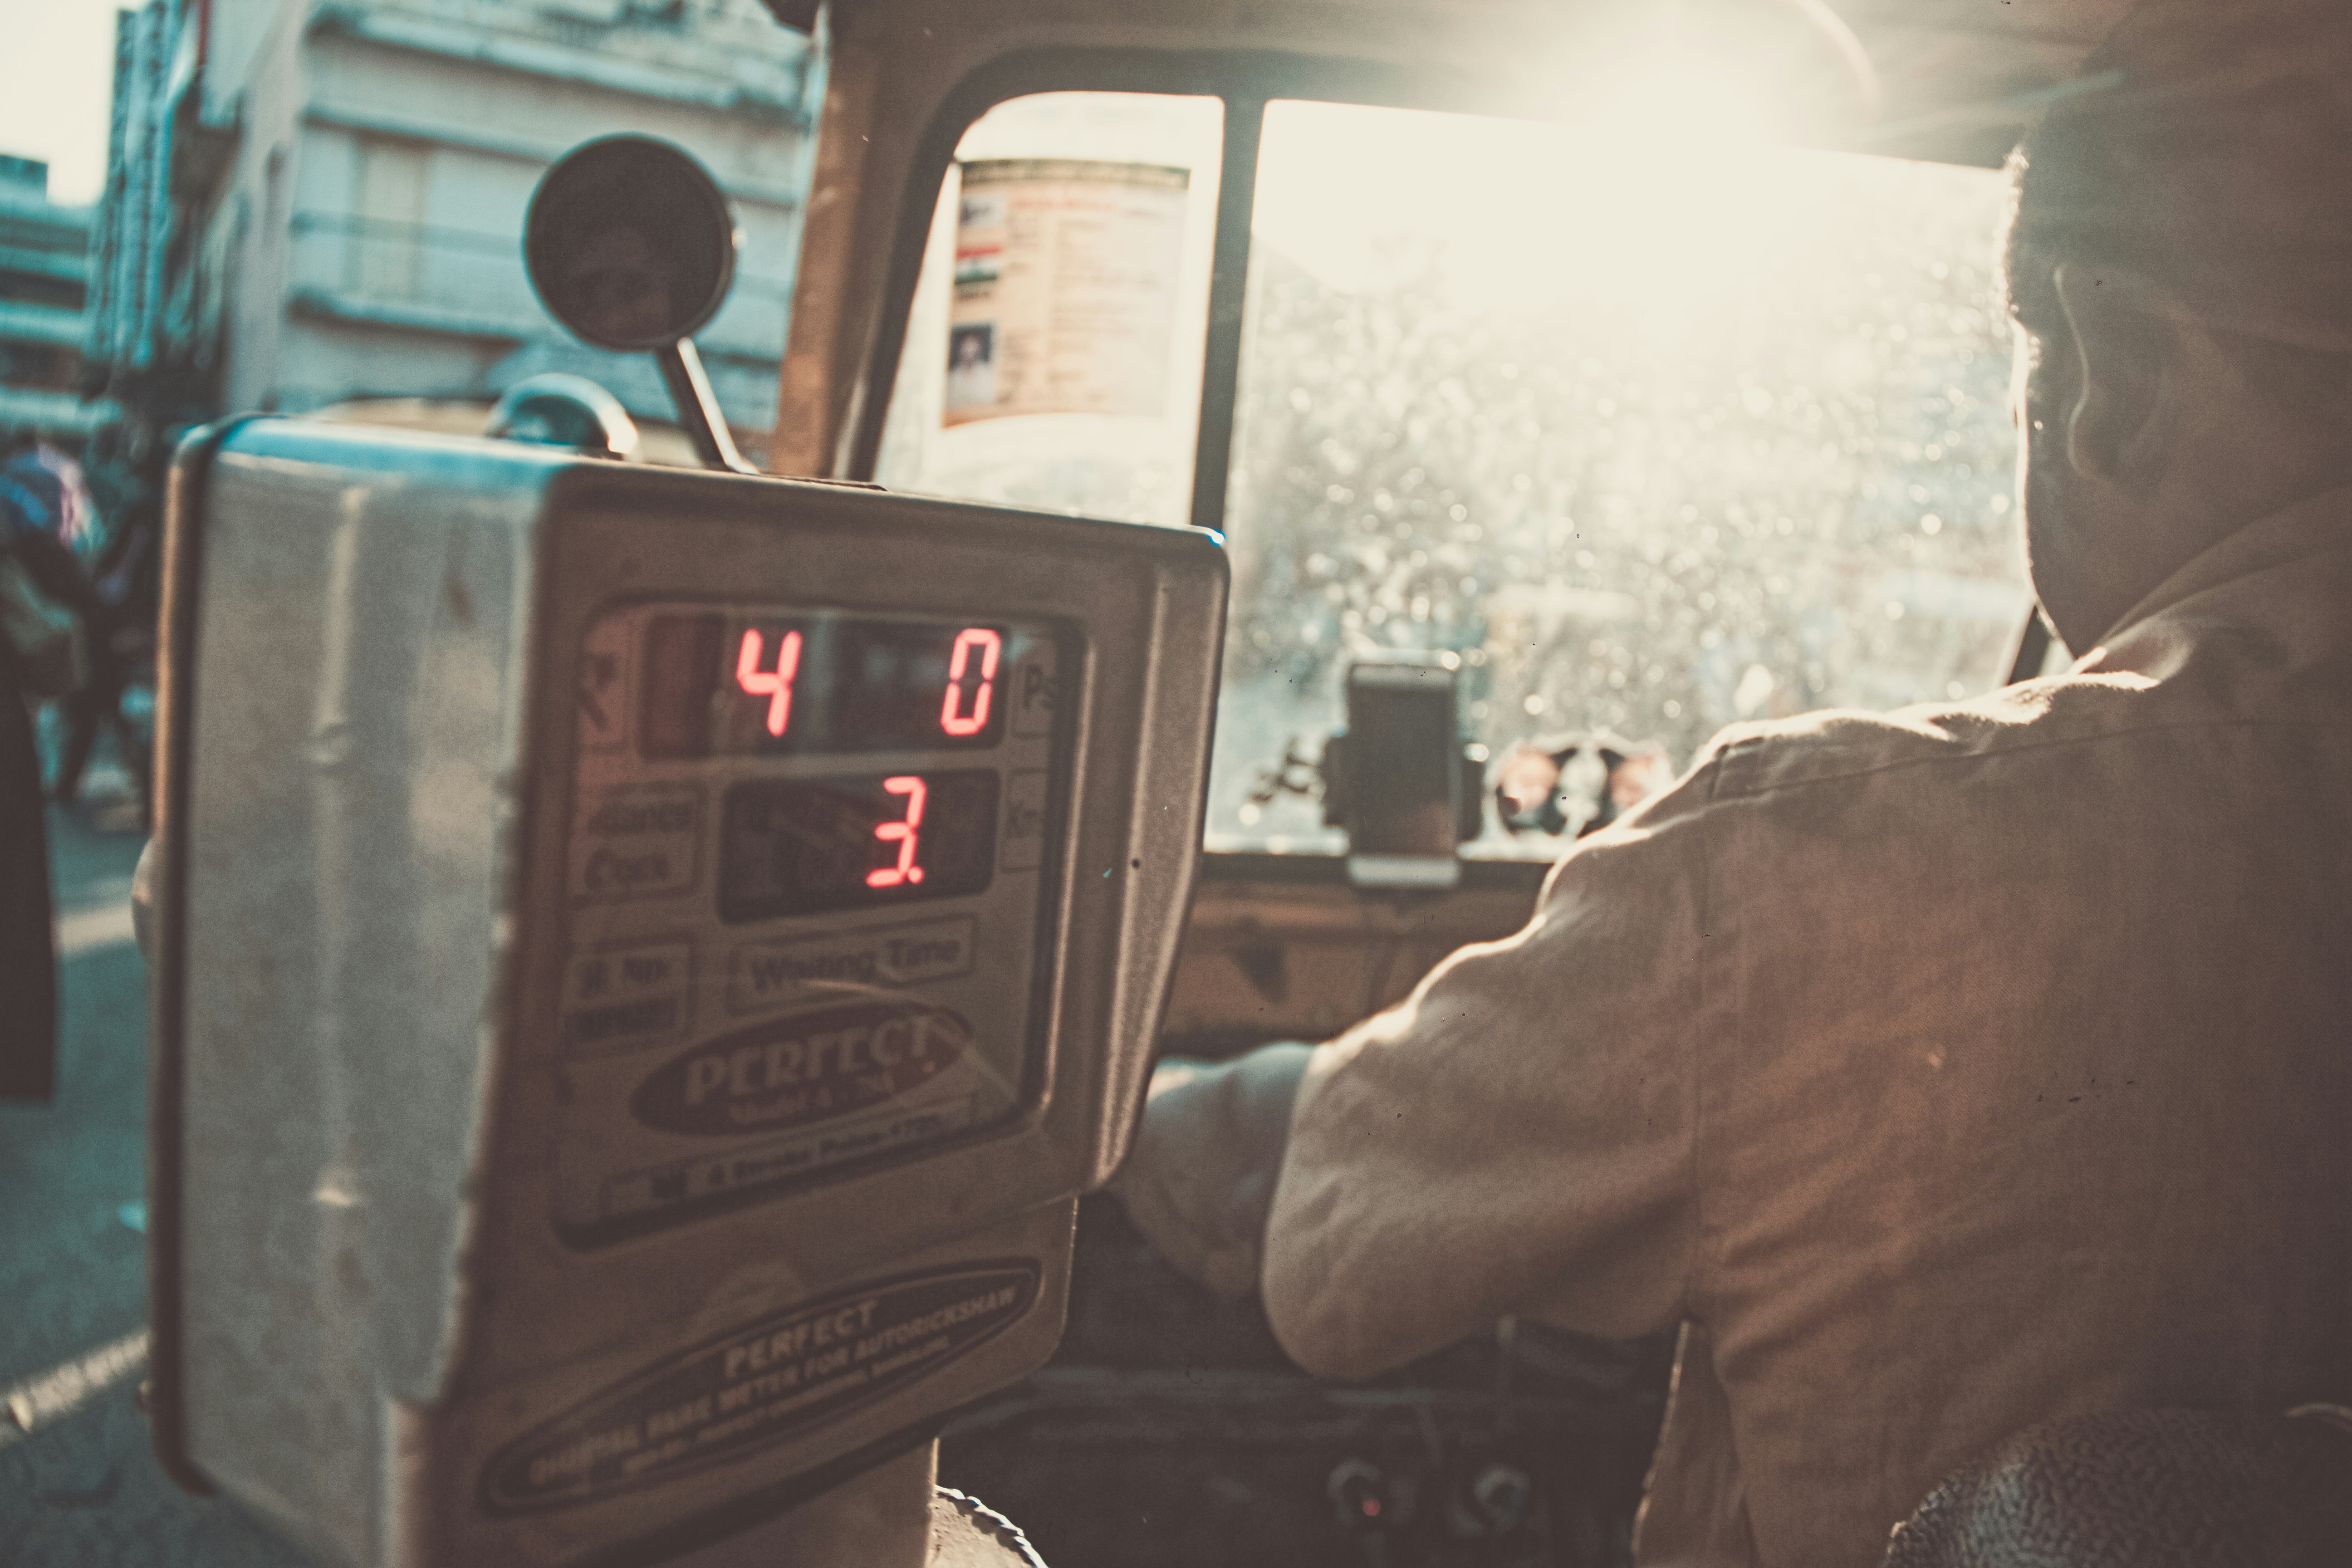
(875, 92), (1223, 522)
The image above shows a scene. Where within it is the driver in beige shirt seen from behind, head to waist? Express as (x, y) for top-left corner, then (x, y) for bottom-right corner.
(1120, 0), (2352, 1568)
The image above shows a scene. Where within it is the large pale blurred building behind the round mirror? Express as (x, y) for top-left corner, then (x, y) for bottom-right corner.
(89, 0), (821, 463)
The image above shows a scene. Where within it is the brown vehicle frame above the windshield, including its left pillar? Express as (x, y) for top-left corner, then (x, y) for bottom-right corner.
(767, 0), (2131, 477)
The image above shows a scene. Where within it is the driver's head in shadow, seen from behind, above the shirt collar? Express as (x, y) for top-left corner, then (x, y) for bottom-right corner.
(2004, 0), (2352, 649)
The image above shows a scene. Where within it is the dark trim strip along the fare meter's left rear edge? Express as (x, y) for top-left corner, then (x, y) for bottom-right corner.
(146, 414), (264, 1498)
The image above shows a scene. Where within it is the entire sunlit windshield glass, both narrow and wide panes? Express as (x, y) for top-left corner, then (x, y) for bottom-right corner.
(877, 94), (2028, 856)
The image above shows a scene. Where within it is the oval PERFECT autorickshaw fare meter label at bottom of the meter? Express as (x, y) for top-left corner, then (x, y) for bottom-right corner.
(480, 1260), (1039, 1514)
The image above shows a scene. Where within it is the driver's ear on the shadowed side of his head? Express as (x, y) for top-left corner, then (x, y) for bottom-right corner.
(2053, 263), (2195, 491)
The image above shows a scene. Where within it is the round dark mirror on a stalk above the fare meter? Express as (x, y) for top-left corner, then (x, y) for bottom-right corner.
(522, 137), (736, 350)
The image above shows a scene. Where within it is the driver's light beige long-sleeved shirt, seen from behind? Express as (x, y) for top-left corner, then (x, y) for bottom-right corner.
(1146, 494), (2352, 1568)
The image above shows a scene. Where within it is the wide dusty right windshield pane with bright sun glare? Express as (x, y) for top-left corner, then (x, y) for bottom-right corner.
(1209, 103), (2028, 856)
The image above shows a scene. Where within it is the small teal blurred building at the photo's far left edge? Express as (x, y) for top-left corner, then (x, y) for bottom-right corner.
(0, 155), (113, 444)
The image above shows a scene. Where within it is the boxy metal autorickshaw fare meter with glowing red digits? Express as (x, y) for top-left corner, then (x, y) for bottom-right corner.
(151, 418), (1225, 1566)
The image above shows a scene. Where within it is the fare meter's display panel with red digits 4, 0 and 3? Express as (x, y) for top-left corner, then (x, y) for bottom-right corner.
(558, 604), (1070, 1234)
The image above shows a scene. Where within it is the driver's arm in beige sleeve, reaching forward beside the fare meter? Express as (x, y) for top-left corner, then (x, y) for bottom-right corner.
(1120, 764), (1731, 1375)
